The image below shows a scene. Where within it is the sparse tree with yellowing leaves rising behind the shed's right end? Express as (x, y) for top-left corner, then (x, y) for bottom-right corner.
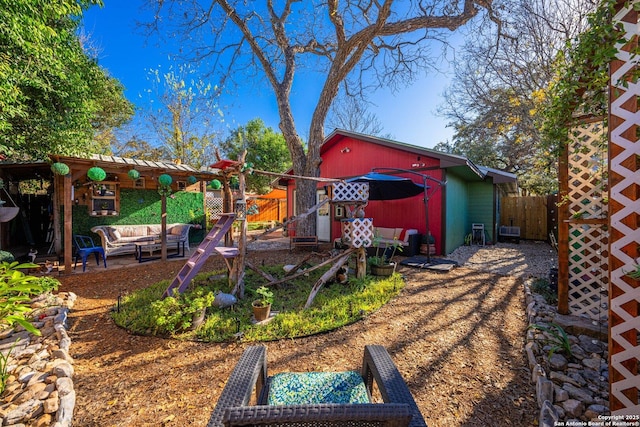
(436, 0), (597, 194)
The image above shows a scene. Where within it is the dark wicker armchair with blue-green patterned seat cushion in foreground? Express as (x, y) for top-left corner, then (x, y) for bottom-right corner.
(207, 345), (426, 427)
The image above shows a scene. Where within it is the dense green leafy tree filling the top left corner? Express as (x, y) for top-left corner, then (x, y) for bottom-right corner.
(0, 0), (133, 159)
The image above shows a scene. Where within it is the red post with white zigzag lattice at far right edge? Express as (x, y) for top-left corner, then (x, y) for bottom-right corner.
(609, 0), (640, 415)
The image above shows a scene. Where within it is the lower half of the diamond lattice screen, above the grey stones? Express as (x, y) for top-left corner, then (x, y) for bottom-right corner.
(569, 224), (609, 321)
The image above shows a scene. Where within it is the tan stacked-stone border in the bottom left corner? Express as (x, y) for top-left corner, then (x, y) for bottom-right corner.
(0, 292), (77, 427)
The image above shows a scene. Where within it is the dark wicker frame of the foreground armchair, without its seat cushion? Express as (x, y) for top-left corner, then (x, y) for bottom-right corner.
(207, 345), (426, 427)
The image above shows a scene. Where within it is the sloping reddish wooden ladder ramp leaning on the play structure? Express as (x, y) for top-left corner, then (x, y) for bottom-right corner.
(162, 213), (238, 298)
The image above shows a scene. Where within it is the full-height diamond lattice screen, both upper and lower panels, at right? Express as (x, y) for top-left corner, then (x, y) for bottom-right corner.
(564, 121), (609, 321)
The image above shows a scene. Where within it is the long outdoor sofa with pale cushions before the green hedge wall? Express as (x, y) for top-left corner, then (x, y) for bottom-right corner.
(91, 224), (191, 256)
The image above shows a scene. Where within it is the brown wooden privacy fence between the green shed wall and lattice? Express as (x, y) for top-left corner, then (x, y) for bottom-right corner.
(498, 196), (557, 241)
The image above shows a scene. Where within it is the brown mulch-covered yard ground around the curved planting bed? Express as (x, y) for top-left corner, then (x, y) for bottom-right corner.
(60, 246), (537, 427)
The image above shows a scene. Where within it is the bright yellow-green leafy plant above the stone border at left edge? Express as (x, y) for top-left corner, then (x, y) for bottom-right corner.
(0, 261), (59, 335)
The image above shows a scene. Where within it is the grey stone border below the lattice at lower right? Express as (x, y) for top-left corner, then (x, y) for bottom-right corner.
(524, 281), (610, 427)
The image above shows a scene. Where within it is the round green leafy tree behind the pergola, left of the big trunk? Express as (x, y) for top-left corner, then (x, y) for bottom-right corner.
(220, 119), (291, 194)
